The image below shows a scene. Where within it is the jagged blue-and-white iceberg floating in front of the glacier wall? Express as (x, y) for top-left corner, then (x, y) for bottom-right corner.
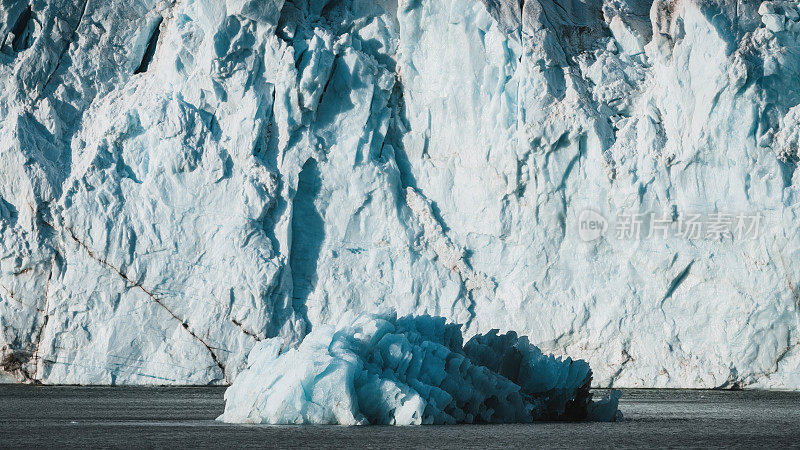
(220, 315), (619, 425)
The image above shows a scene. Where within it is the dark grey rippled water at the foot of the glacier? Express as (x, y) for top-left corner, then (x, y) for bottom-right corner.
(0, 385), (800, 448)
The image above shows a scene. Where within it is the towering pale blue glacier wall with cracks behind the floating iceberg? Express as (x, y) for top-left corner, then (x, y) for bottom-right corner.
(0, 0), (800, 389)
